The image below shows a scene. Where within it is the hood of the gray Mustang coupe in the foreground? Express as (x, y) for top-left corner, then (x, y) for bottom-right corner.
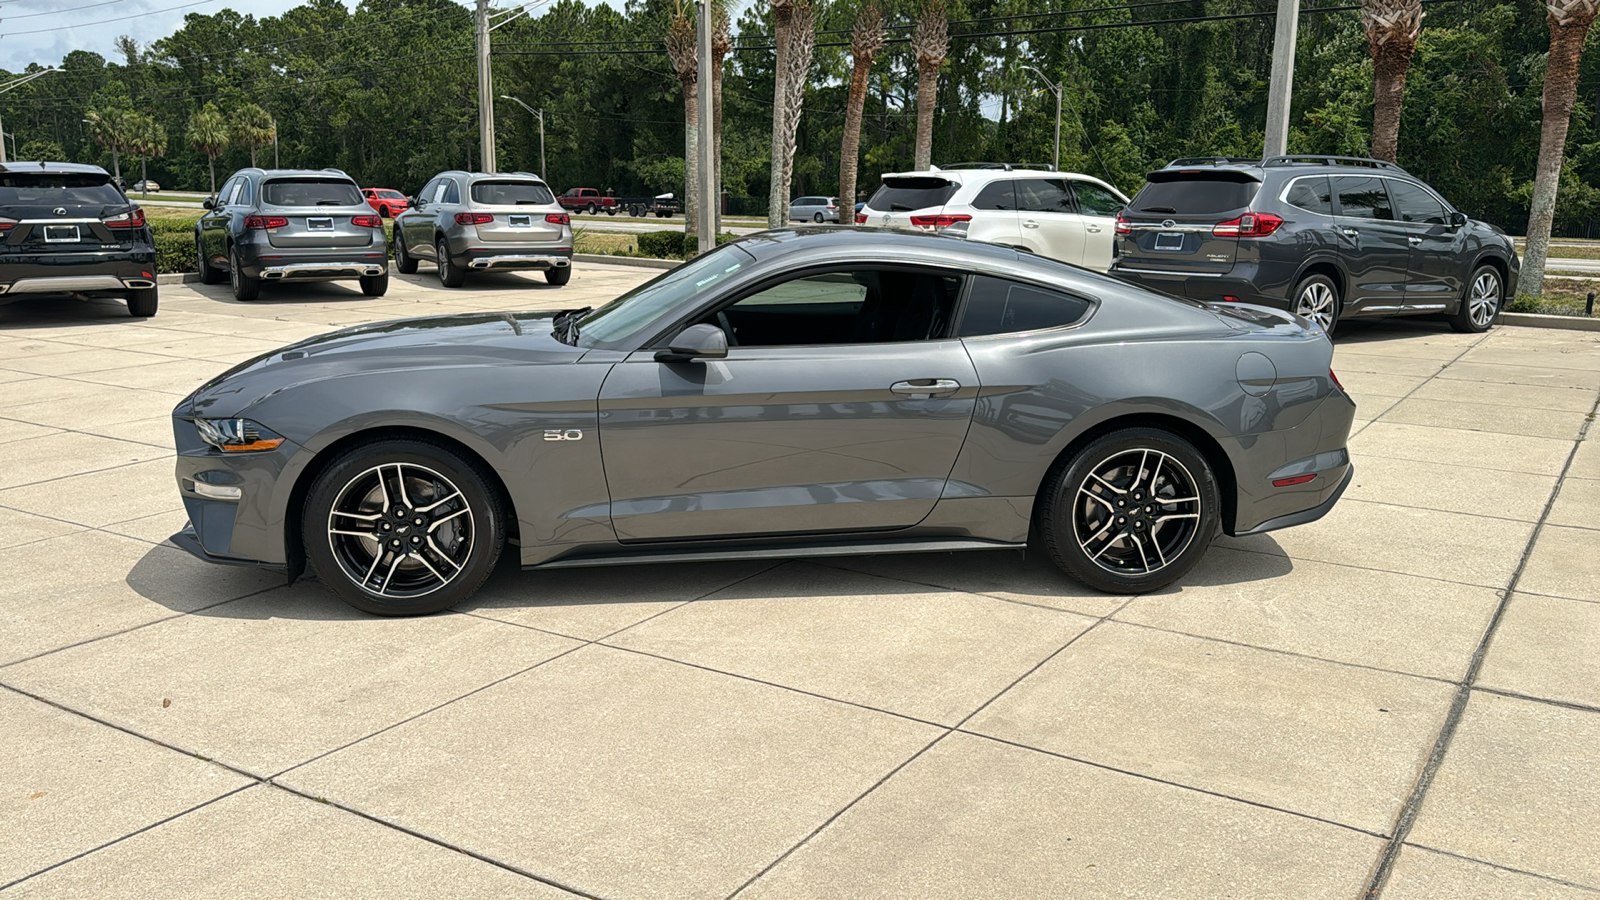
(173, 311), (584, 418)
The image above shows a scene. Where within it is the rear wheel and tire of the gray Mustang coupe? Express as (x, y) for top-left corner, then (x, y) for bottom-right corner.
(1038, 428), (1222, 594)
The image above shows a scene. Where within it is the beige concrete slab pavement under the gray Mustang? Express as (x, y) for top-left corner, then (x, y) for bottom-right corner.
(0, 266), (1600, 900)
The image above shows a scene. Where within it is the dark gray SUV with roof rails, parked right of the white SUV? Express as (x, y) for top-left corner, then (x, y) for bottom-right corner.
(1110, 155), (1520, 335)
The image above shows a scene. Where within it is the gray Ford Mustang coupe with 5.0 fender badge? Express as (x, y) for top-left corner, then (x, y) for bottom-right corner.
(173, 227), (1355, 615)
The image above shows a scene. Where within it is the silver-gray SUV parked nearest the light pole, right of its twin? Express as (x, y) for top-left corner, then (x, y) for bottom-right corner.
(395, 171), (573, 288)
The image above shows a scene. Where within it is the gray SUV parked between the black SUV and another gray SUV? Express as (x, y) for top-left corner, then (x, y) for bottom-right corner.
(195, 168), (389, 301)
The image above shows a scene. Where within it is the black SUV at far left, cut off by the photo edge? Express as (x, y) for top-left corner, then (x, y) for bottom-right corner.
(0, 162), (157, 317)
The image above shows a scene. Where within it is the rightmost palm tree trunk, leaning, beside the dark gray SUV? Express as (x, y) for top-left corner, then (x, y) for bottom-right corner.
(1520, 0), (1600, 296)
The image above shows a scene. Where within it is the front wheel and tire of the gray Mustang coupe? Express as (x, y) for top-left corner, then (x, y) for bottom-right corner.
(301, 439), (506, 615)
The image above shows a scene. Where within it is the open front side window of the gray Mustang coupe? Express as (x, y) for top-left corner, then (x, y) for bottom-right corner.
(701, 269), (962, 348)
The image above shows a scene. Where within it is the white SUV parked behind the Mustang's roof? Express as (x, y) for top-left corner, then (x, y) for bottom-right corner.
(856, 163), (1128, 272)
